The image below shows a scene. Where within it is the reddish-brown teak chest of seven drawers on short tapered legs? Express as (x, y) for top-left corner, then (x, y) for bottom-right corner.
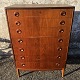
(5, 4), (75, 77)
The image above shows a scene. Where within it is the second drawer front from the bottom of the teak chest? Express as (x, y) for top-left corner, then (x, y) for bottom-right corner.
(15, 53), (66, 62)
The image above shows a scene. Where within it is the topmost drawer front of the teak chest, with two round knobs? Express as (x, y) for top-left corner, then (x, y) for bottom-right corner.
(7, 9), (73, 18)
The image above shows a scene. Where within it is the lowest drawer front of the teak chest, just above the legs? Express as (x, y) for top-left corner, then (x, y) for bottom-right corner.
(16, 60), (66, 70)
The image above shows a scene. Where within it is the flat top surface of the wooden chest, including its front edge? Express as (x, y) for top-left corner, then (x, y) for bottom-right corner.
(5, 4), (75, 9)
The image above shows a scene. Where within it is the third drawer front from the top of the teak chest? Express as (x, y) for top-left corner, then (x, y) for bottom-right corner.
(10, 26), (71, 38)
